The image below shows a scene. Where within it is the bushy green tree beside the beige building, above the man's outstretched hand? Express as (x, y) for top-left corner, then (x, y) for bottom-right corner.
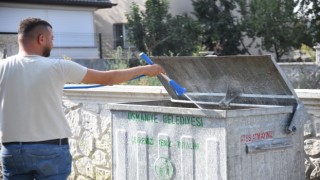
(127, 0), (198, 56)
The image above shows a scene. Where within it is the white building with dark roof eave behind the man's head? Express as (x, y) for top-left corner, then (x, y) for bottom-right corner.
(0, 0), (116, 59)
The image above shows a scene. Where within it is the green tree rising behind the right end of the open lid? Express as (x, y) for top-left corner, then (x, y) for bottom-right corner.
(238, 0), (310, 61)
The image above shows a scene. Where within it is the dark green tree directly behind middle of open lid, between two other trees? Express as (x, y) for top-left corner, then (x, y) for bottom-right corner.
(192, 0), (243, 55)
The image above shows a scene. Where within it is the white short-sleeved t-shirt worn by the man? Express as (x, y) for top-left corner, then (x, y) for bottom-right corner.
(0, 55), (87, 142)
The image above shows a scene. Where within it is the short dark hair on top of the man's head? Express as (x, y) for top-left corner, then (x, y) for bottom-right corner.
(18, 18), (52, 36)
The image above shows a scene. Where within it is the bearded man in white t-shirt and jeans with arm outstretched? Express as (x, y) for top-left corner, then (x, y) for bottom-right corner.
(0, 18), (164, 180)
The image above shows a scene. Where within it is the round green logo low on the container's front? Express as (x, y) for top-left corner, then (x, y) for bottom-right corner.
(154, 157), (173, 180)
